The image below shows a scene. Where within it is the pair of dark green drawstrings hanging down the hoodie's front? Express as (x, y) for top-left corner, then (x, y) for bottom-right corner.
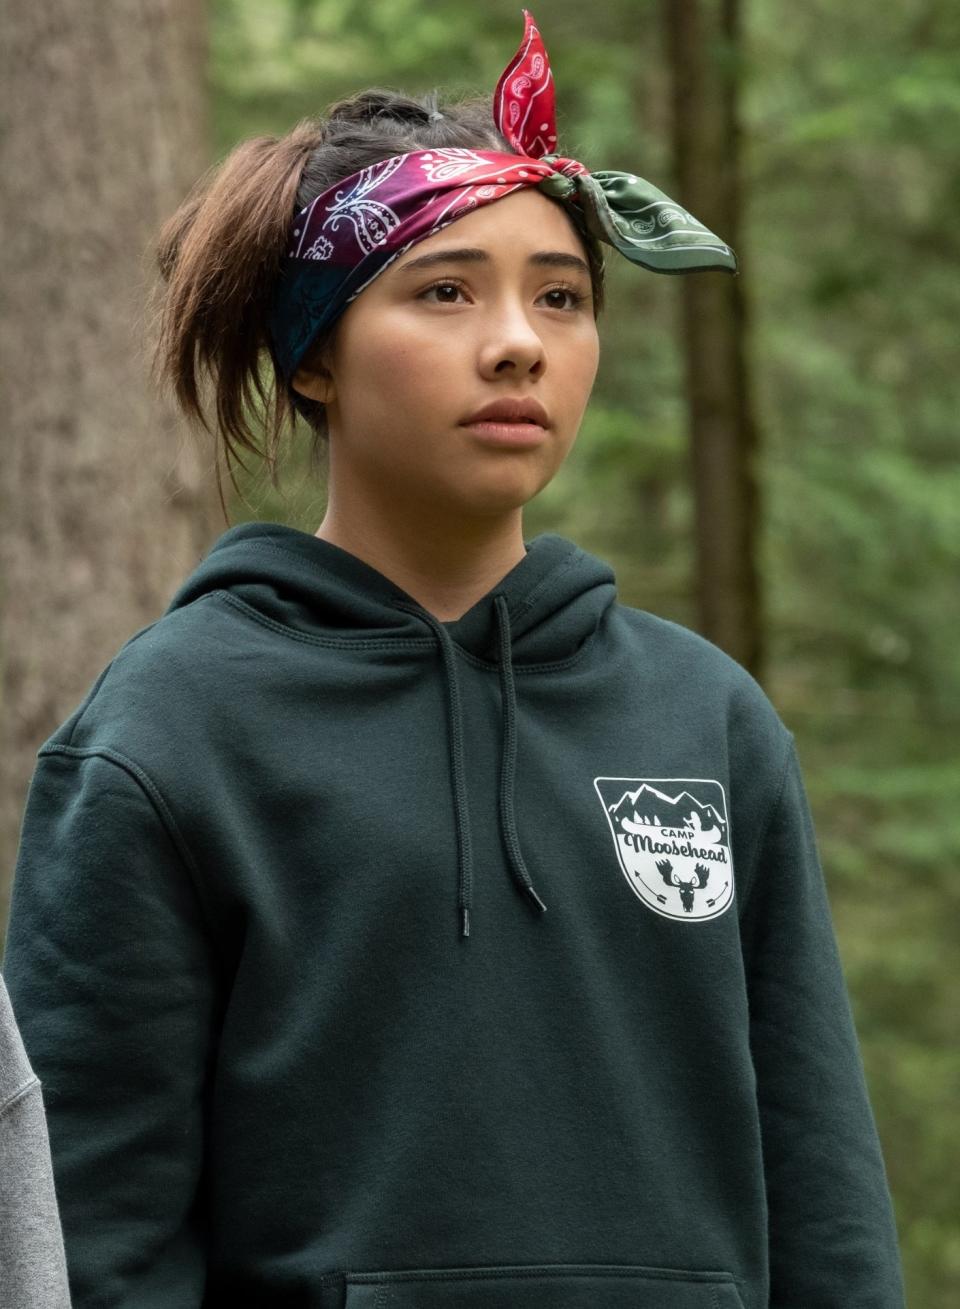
(385, 594), (546, 936)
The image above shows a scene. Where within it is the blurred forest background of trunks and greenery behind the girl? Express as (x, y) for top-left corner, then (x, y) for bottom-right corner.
(0, 0), (960, 1309)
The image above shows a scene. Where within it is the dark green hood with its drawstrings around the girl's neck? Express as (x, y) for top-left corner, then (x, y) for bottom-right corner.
(166, 522), (617, 936)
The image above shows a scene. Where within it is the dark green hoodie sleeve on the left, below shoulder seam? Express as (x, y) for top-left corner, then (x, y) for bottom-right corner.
(4, 745), (217, 1309)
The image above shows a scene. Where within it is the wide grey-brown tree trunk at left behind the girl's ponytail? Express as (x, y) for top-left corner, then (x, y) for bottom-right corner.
(0, 0), (223, 939)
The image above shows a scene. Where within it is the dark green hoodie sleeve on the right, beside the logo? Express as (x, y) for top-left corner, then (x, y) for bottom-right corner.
(741, 733), (904, 1309)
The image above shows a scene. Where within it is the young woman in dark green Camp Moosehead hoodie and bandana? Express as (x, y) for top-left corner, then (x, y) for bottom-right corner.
(7, 13), (902, 1309)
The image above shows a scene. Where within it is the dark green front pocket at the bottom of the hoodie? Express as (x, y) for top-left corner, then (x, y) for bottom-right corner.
(346, 1263), (744, 1309)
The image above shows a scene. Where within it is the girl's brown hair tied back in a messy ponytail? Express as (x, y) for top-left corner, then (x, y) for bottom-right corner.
(152, 86), (604, 517)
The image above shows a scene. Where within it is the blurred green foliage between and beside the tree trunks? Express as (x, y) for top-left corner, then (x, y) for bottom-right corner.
(211, 0), (960, 1309)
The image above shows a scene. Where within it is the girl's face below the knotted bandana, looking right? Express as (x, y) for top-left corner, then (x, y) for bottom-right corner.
(295, 187), (600, 521)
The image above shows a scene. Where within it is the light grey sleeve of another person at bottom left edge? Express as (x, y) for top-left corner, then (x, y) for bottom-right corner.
(0, 975), (71, 1309)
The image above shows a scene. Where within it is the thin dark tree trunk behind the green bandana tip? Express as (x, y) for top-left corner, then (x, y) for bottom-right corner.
(663, 0), (764, 679)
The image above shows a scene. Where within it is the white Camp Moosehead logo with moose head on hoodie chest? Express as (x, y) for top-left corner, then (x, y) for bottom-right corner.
(593, 778), (733, 923)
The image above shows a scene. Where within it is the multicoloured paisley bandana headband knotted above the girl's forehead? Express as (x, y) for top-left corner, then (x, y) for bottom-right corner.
(267, 9), (737, 382)
